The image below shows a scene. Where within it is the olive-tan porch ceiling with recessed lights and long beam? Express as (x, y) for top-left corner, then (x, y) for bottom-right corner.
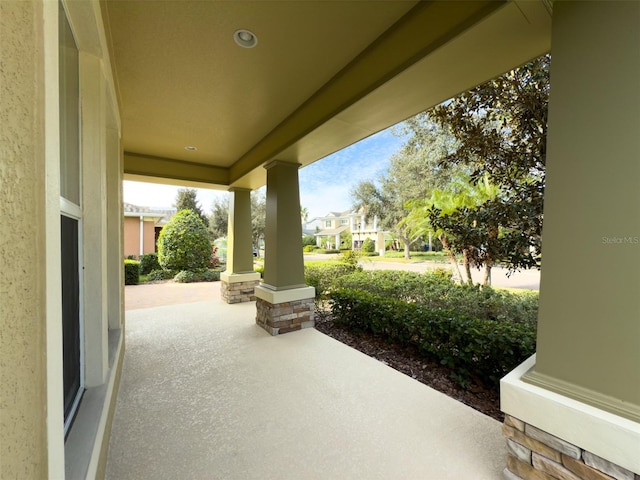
(102, 0), (551, 188)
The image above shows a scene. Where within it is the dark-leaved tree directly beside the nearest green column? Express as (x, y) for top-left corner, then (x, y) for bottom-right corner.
(429, 55), (550, 270)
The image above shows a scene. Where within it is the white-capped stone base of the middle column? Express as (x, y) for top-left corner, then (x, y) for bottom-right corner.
(256, 286), (315, 335)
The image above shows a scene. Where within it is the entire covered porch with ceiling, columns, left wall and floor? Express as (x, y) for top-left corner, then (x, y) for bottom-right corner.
(0, 0), (640, 480)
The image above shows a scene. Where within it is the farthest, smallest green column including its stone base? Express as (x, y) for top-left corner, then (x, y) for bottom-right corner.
(220, 188), (260, 303)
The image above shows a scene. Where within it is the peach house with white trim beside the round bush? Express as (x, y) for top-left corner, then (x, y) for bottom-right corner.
(124, 203), (176, 257)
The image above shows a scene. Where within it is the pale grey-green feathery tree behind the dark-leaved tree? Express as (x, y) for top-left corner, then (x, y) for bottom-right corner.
(351, 116), (454, 258)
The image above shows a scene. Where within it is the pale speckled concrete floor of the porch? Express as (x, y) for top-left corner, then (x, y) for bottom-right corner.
(107, 283), (506, 480)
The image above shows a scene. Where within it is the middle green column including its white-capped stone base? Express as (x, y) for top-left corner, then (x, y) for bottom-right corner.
(256, 160), (315, 335)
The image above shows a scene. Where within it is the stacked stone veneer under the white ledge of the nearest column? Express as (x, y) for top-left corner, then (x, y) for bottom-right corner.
(502, 415), (640, 480)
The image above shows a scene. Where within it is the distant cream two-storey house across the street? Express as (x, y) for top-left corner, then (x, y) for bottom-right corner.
(307, 210), (385, 254)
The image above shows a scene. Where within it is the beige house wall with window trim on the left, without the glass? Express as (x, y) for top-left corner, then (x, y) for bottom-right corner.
(0, 0), (123, 479)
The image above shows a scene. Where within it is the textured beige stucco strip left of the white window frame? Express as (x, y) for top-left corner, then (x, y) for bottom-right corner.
(0, 0), (47, 478)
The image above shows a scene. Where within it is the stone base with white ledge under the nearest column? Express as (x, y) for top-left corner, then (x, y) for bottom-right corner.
(500, 355), (640, 480)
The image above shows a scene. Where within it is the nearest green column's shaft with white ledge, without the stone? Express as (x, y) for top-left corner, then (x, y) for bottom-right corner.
(501, 1), (640, 478)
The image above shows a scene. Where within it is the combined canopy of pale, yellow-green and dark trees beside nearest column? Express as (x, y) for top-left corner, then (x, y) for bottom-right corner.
(352, 55), (550, 283)
